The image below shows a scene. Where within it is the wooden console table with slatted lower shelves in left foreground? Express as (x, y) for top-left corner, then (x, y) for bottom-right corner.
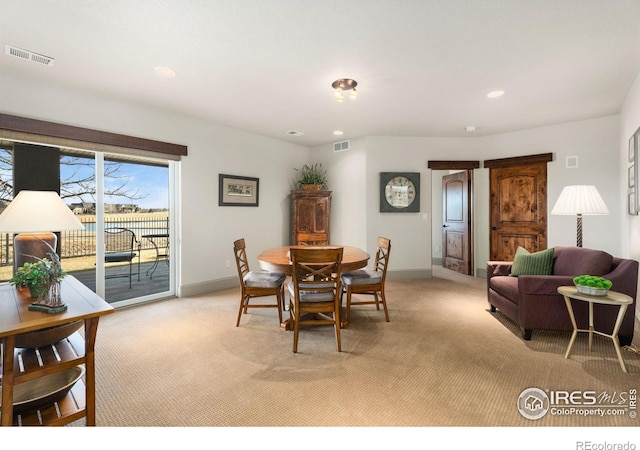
(0, 276), (113, 426)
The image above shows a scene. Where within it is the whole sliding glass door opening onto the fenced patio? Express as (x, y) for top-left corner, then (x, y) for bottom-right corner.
(0, 143), (177, 306)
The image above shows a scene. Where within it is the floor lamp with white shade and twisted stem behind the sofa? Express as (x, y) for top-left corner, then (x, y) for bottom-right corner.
(551, 185), (609, 247)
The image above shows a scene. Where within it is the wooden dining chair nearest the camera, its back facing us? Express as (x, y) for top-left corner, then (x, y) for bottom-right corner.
(289, 247), (344, 353)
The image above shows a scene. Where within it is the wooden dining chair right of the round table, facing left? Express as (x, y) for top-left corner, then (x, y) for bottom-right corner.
(340, 237), (391, 327)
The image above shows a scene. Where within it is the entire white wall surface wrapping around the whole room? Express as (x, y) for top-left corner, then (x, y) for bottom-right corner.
(0, 73), (640, 308)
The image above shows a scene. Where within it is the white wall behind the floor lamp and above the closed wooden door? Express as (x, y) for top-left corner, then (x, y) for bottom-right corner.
(478, 116), (626, 256)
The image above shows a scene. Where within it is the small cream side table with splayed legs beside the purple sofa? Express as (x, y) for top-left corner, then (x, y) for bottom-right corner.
(558, 286), (633, 372)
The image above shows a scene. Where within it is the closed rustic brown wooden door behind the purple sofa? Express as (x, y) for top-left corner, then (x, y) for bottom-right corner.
(485, 155), (551, 261)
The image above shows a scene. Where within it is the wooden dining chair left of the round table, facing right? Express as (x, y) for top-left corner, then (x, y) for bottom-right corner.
(233, 239), (287, 327)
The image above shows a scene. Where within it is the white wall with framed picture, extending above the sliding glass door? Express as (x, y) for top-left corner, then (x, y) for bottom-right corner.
(0, 73), (310, 295)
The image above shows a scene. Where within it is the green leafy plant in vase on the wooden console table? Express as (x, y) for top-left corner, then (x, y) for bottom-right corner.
(10, 241), (67, 313)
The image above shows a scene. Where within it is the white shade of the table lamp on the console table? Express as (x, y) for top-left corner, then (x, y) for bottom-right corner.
(0, 191), (84, 233)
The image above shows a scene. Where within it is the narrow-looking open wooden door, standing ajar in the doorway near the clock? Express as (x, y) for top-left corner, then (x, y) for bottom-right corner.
(442, 170), (473, 275)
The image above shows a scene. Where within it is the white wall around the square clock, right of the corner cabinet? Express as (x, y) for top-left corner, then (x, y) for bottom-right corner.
(312, 136), (473, 277)
